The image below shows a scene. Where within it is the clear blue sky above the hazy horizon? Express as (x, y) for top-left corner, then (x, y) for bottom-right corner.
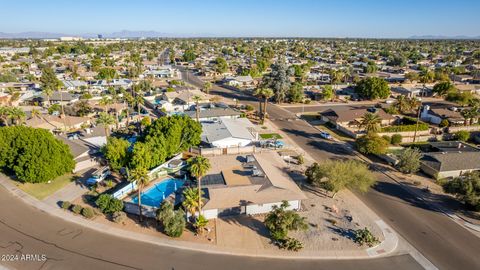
(0, 0), (480, 38)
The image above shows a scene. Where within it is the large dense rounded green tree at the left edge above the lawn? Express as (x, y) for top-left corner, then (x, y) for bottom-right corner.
(0, 126), (75, 183)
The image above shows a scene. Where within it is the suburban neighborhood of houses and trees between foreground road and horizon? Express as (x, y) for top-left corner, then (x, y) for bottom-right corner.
(0, 36), (480, 268)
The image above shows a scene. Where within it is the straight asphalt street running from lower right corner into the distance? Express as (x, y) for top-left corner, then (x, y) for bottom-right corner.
(179, 69), (480, 269)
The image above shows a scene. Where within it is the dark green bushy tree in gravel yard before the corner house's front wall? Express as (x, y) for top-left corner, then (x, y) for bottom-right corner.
(264, 201), (308, 246)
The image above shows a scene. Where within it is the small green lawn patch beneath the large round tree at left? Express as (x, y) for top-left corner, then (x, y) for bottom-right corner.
(15, 173), (74, 200)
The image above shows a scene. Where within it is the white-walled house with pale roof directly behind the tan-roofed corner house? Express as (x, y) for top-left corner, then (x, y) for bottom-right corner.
(202, 118), (258, 148)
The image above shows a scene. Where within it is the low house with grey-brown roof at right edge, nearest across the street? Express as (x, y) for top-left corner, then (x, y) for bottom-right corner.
(420, 142), (480, 179)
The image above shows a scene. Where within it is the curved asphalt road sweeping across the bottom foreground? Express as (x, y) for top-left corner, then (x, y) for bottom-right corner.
(0, 187), (422, 270)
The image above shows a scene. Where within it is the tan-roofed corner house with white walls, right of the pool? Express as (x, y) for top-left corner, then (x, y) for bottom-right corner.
(202, 152), (306, 219)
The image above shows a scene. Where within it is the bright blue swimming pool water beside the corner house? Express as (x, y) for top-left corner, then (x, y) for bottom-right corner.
(132, 178), (184, 207)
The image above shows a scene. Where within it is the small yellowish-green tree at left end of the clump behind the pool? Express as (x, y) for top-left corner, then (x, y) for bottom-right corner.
(102, 137), (130, 171)
